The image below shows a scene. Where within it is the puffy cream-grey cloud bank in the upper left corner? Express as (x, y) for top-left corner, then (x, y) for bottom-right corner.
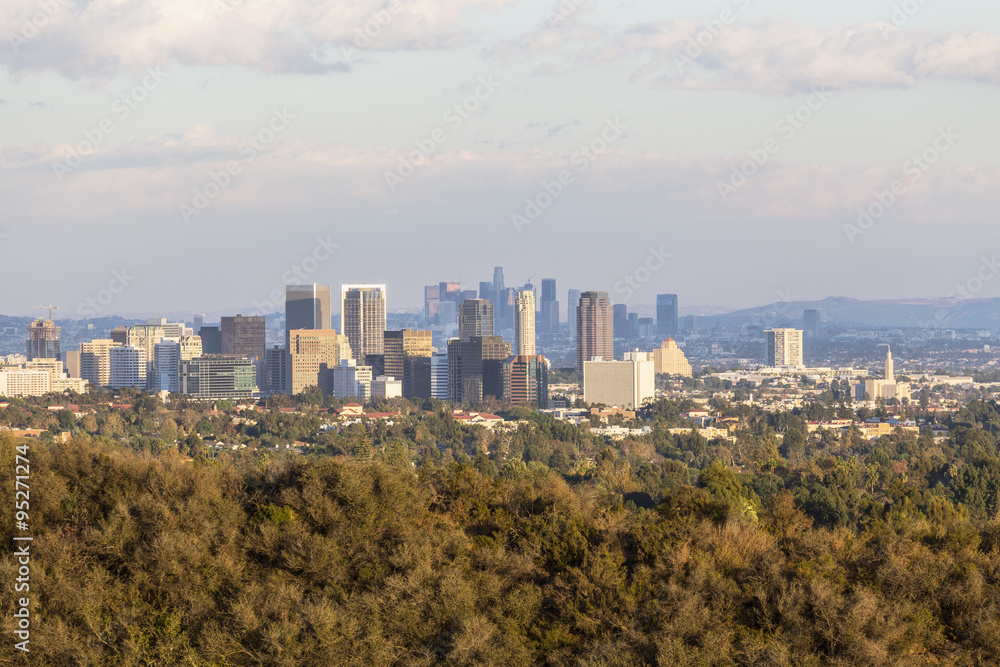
(0, 0), (519, 79)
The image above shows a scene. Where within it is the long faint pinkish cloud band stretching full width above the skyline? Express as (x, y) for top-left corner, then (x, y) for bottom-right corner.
(0, 126), (1000, 226)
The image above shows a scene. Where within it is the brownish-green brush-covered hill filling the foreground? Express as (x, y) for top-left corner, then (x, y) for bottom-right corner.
(0, 435), (1000, 667)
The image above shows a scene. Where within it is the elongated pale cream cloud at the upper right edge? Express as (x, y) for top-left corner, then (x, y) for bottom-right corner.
(496, 17), (1000, 94)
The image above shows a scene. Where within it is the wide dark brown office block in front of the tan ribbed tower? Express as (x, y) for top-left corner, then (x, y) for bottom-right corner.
(448, 336), (510, 403)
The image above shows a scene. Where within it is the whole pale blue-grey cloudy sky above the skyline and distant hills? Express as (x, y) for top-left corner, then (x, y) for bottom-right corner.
(0, 0), (1000, 317)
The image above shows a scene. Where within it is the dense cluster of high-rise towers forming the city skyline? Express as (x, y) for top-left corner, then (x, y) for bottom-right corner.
(21, 267), (678, 406)
